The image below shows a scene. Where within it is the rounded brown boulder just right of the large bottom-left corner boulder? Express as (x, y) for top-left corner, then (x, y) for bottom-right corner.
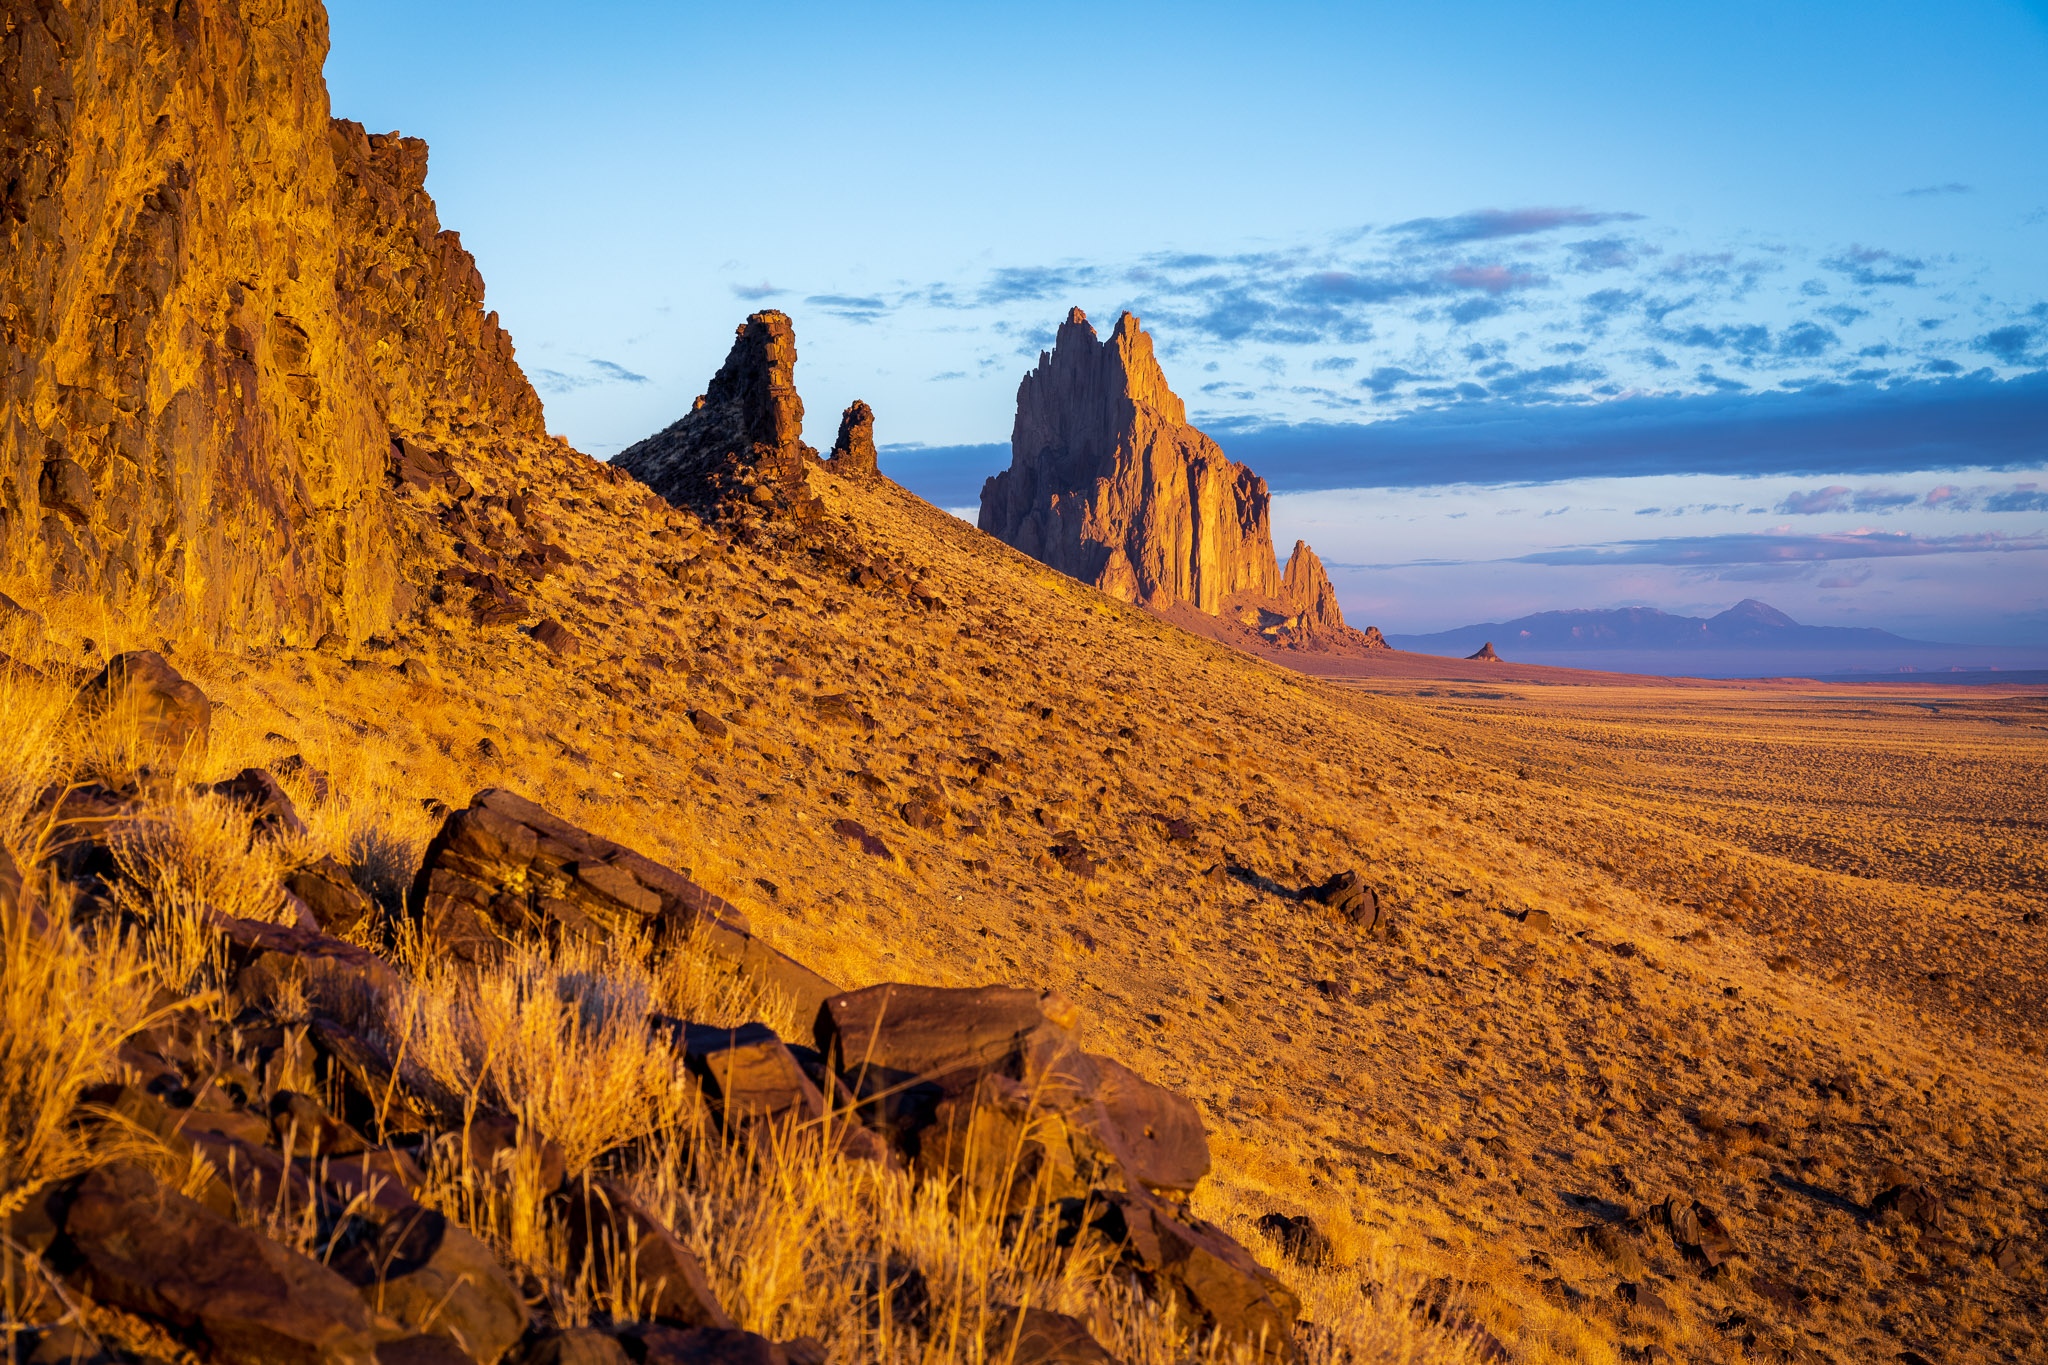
(330, 1205), (526, 1365)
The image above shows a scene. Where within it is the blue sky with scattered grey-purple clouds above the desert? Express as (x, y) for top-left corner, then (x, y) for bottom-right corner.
(328, 0), (2048, 651)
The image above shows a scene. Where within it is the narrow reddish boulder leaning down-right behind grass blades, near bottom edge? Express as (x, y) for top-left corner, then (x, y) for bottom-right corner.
(551, 1177), (733, 1326)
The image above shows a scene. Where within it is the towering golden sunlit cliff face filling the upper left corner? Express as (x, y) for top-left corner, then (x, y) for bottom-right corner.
(0, 0), (543, 643)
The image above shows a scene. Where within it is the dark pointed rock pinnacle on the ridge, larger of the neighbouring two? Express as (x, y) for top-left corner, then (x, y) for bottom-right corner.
(612, 309), (817, 518)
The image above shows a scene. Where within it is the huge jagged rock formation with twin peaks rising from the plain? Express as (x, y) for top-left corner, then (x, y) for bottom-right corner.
(979, 309), (1370, 647)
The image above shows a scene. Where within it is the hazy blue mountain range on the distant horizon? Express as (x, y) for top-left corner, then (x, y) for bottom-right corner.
(1386, 598), (1952, 659)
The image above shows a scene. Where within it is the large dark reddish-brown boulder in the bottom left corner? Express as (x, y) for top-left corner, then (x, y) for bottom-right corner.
(51, 1164), (377, 1365)
